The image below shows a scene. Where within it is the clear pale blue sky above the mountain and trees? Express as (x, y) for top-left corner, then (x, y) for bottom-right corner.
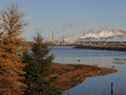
(0, 0), (126, 39)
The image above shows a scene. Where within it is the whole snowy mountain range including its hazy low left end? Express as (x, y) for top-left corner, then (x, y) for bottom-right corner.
(64, 29), (126, 43)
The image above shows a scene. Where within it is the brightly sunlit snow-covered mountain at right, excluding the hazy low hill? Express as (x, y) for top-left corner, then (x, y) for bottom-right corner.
(79, 29), (126, 41)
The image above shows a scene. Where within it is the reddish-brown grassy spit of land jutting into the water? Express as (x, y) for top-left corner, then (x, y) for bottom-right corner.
(48, 64), (117, 91)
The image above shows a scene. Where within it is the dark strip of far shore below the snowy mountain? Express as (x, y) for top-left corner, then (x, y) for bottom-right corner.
(75, 41), (126, 51)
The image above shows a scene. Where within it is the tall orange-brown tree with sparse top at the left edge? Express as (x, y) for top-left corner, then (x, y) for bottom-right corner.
(0, 5), (25, 95)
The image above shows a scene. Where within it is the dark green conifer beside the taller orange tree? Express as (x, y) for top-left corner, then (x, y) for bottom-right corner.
(24, 34), (61, 95)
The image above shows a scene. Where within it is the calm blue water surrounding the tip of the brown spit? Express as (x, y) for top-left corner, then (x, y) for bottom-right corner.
(52, 48), (126, 95)
